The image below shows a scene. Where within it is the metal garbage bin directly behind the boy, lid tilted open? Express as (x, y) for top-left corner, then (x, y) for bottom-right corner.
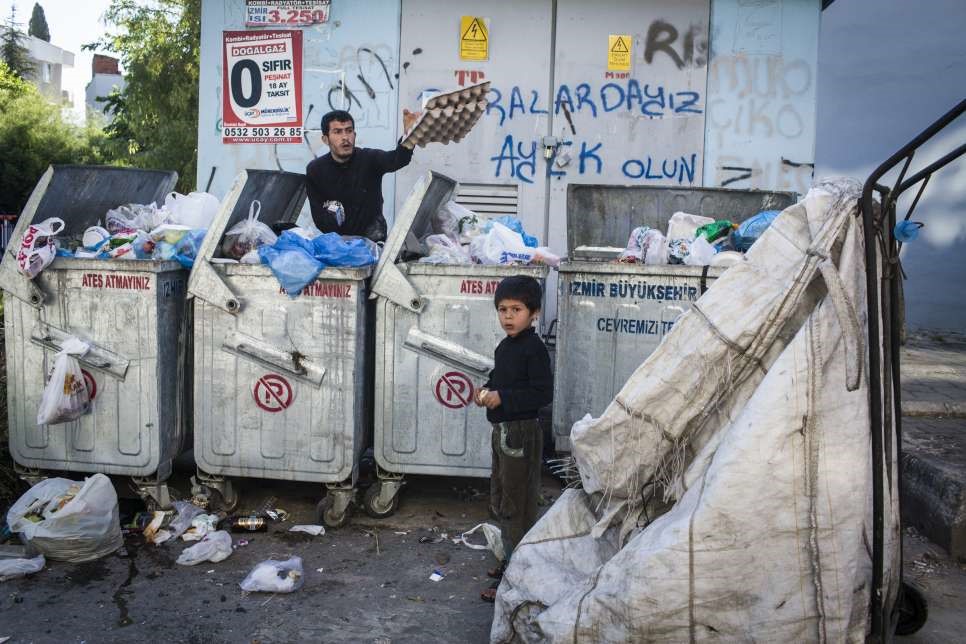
(363, 172), (548, 518)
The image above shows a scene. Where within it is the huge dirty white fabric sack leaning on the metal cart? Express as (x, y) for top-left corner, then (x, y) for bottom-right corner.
(491, 180), (899, 643)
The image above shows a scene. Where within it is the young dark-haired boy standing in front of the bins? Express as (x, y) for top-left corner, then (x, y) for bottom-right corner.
(476, 276), (553, 602)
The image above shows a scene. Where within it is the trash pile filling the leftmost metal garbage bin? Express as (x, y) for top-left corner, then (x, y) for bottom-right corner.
(17, 192), (219, 279)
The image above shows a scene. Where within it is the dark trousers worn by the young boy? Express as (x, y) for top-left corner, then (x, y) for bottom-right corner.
(490, 418), (543, 560)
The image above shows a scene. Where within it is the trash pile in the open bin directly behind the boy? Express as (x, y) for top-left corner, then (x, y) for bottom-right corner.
(419, 201), (560, 266)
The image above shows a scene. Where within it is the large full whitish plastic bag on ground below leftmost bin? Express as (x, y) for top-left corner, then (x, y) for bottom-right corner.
(7, 474), (123, 562)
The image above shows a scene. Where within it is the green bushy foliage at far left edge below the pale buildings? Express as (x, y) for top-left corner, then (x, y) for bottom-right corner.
(0, 64), (107, 213)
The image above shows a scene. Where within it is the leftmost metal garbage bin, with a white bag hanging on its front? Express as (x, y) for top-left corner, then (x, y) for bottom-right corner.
(0, 166), (188, 507)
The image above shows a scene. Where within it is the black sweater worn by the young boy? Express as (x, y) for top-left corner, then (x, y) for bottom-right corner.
(483, 327), (553, 423)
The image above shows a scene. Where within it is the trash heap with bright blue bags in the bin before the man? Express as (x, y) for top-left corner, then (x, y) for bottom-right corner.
(213, 200), (380, 298)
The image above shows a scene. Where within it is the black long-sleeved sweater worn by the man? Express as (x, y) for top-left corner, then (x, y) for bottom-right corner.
(305, 145), (413, 241)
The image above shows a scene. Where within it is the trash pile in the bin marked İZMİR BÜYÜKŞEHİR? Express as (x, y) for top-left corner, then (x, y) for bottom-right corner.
(617, 210), (779, 266)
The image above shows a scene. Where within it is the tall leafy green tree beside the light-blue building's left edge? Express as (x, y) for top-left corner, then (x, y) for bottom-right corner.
(84, 0), (201, 192)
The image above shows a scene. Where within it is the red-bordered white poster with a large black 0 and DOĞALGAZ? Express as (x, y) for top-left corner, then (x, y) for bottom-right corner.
(222, 31), (302, 143)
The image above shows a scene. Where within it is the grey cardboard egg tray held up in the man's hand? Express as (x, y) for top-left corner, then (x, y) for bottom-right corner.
(403, 81), (490, 148)
